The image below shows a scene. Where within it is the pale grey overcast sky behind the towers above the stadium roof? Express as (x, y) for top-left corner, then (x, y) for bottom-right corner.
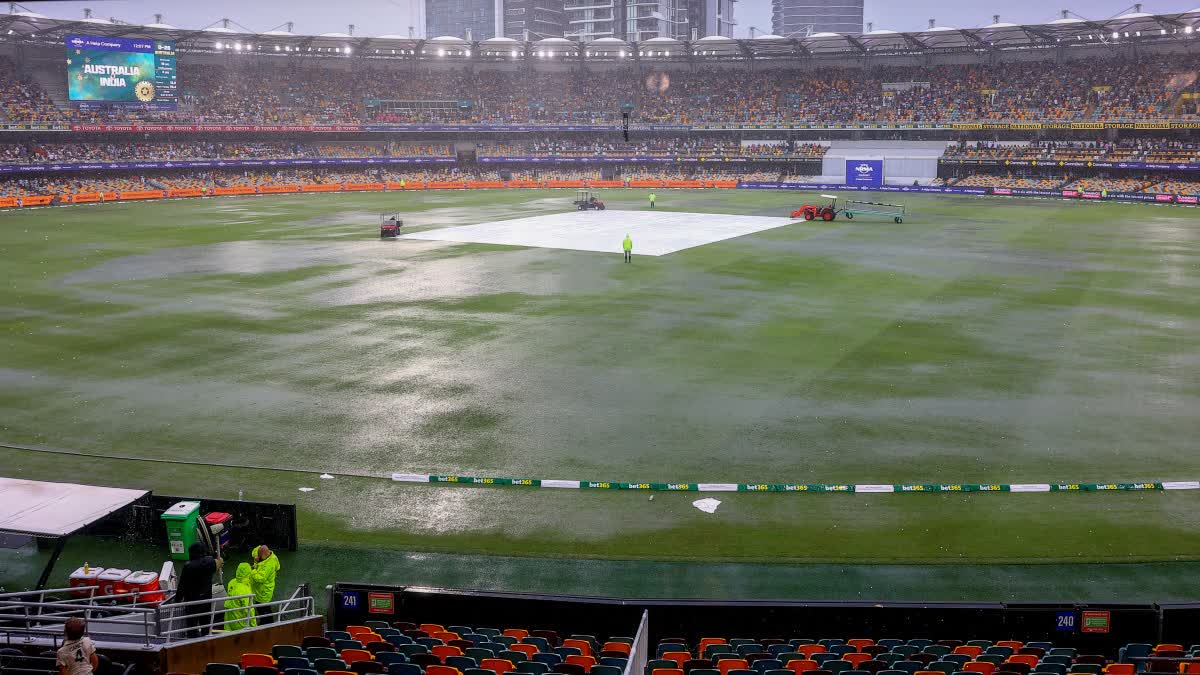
(16, 0), (1200, 37)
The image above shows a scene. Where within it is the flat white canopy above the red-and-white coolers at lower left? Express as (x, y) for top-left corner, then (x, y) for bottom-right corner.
(0, 477), (146, 537)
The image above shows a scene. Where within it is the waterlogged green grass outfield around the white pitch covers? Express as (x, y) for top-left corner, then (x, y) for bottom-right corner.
(0, 190), (1200, 595)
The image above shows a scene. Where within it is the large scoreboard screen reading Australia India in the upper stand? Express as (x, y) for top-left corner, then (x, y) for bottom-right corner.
(66, 35), (178, 109)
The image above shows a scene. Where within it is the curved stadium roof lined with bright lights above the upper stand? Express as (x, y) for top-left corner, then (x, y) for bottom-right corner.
(0, 7), (1200, 60)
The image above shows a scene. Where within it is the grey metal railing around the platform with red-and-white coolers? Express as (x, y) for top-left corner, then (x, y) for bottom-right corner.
(0, 586), (316, 649)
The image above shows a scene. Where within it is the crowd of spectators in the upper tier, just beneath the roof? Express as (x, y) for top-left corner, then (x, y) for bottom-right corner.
(0, 54), (1200, 125)
